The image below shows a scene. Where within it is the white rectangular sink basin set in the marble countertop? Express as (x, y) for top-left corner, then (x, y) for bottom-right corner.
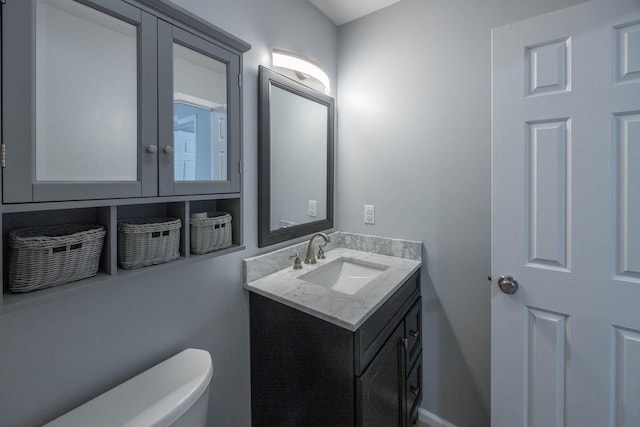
(298, 257), (389, 295)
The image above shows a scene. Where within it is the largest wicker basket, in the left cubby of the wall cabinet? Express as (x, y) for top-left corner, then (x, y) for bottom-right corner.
(9, 224), (106, 292)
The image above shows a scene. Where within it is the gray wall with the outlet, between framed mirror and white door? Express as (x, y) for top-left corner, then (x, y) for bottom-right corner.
(336, 0), (582, 426)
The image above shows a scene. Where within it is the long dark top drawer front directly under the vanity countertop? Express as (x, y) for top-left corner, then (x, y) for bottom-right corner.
(354, 271), (420, 375)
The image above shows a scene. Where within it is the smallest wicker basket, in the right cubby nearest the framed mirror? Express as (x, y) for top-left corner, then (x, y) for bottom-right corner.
(189, 212), (231, 255)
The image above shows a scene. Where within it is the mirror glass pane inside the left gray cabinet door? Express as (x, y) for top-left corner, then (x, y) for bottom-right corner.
(35, 0), (138, 181)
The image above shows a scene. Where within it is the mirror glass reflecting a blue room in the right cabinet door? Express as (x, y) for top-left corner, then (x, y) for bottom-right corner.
(173, 44), (227, 181)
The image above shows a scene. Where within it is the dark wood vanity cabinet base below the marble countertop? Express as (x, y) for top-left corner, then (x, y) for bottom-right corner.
(250, 272), (422, 427)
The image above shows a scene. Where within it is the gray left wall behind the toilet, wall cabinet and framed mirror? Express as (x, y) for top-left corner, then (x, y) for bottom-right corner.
(0, 0), (337, 427)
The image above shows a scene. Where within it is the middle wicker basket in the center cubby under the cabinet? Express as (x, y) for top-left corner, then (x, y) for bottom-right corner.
(118, 218), (182, 269)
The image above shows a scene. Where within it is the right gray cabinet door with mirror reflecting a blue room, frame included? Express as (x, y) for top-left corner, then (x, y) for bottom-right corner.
(158, 21), (240, 195)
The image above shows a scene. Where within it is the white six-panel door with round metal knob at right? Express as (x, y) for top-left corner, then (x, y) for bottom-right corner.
(491, 0), (640, 427)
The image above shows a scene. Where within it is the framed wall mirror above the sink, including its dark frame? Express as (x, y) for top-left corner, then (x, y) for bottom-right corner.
(258, 66), (334, 247)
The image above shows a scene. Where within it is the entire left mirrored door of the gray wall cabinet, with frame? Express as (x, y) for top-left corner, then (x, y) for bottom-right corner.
(2, 0), (157, 203)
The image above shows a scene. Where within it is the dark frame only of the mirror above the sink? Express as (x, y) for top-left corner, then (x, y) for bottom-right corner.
(258, 66), (334, 248)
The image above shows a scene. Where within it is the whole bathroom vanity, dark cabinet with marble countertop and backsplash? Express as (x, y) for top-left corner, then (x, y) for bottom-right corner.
(245, 232), (422, 427)
